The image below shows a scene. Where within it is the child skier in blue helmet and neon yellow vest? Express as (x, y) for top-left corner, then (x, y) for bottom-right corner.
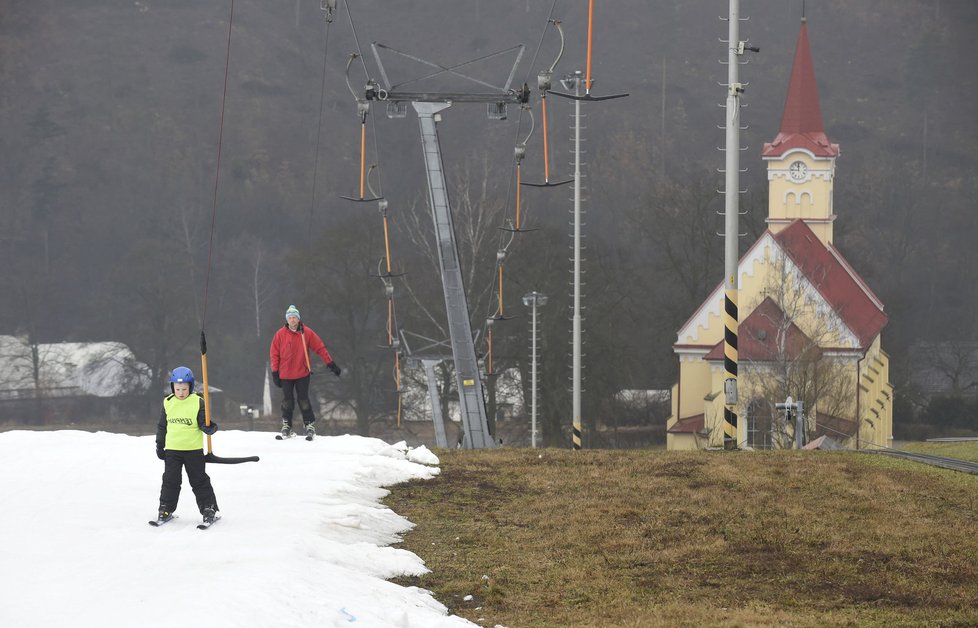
(150, 366), (218, 525)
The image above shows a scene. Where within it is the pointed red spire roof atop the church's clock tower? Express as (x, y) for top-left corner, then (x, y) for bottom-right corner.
(761, 18), (839, 157)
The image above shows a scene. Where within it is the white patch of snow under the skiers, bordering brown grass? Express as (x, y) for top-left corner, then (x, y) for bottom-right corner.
(0, 431), (474, 628)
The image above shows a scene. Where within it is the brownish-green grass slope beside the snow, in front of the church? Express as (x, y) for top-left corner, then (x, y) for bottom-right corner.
(386, 444), (978, 628)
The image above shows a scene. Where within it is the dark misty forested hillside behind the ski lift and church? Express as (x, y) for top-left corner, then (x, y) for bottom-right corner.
(0, 0), (978, 430)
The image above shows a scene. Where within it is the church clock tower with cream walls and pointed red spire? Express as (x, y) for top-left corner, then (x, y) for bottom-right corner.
(761, 18), (839, 244)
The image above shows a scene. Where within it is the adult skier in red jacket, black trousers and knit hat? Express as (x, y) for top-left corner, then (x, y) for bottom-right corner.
(269, 305), (341, 440)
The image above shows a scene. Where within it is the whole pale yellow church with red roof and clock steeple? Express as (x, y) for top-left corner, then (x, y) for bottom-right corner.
(666, 18), (893, 450)
